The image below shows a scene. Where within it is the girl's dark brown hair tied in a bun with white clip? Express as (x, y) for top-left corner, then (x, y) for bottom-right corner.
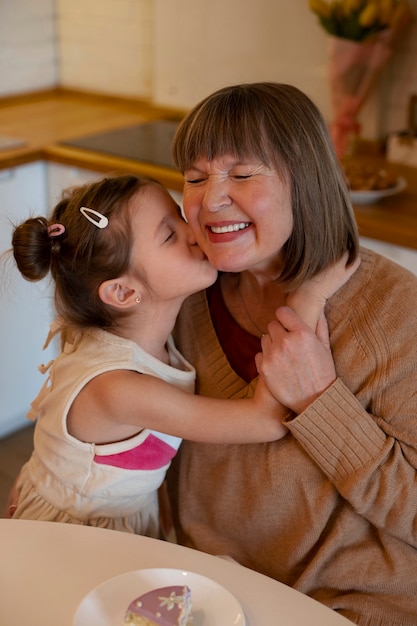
(12, 175), (160, 328)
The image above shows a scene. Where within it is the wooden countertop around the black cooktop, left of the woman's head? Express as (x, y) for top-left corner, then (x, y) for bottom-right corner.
(0, 89), (184, 191)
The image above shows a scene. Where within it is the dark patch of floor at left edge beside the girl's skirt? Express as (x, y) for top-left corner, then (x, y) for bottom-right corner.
(0, 426), (33, 517)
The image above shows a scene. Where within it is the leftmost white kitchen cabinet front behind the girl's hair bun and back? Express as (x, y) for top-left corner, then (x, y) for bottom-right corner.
(0, 162), (53, 437)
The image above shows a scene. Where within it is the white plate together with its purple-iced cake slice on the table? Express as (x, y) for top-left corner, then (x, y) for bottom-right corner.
(73, 568), (246, 626)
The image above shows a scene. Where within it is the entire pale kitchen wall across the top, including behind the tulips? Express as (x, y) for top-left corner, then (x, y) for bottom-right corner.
(0, 0), (417, 138)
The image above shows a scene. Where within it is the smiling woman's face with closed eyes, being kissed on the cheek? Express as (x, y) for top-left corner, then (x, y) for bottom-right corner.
(184, 154), (293, 274)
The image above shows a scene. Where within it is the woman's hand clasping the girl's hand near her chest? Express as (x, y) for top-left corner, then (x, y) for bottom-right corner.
(256, 306), (336, 414)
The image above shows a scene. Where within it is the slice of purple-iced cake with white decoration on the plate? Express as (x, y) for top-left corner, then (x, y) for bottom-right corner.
(124, 585), (193, 626)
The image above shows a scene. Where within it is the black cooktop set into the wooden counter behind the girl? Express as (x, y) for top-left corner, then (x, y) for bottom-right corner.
(61, 120), (179, 168)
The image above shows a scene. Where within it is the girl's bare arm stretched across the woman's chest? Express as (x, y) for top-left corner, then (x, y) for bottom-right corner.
(67, 370), (288, 444)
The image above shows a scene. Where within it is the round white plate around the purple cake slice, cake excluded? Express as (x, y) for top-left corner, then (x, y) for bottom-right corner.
(73, 569), (245, 626)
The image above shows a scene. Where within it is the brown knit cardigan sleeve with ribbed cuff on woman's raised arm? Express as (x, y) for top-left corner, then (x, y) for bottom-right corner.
(286, 249), (417, 547)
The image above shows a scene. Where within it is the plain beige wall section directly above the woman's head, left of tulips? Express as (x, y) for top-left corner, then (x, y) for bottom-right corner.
(154, 0), (326, 107)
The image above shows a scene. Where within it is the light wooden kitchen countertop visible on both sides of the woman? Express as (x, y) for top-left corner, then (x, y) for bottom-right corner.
(0, 89), (417, 249)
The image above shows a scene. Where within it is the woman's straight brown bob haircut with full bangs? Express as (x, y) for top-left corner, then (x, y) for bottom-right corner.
(173, 83), (359, 288)
